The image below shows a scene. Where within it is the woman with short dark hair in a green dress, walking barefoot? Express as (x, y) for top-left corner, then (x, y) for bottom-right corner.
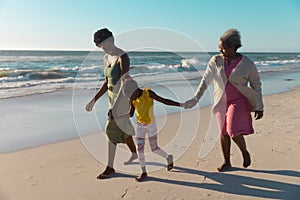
(86, 28), (137, 179)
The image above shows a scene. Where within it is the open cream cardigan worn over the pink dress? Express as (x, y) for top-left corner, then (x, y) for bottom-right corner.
(195, 54), (264, 113)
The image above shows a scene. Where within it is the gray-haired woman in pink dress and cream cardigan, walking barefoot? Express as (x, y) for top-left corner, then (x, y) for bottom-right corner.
(185, 29), (263, 171)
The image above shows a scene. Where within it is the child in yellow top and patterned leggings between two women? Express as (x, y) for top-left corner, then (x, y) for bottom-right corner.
(108, 80), (183, 182)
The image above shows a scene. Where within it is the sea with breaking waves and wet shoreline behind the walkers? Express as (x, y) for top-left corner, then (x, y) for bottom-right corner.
(0, 50), (300, 153)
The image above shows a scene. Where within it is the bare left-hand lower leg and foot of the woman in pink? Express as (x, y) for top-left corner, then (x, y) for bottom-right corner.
(217, 134), (231, 172)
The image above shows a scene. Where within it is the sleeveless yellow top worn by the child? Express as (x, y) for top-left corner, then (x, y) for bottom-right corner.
(132, 88), (155, 124)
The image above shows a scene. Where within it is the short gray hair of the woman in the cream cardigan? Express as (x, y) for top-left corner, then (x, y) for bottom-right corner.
(220, 28), (242, 49)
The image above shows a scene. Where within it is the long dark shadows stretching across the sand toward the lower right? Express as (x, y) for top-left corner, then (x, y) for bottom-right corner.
(148, 167), (300, 200)
